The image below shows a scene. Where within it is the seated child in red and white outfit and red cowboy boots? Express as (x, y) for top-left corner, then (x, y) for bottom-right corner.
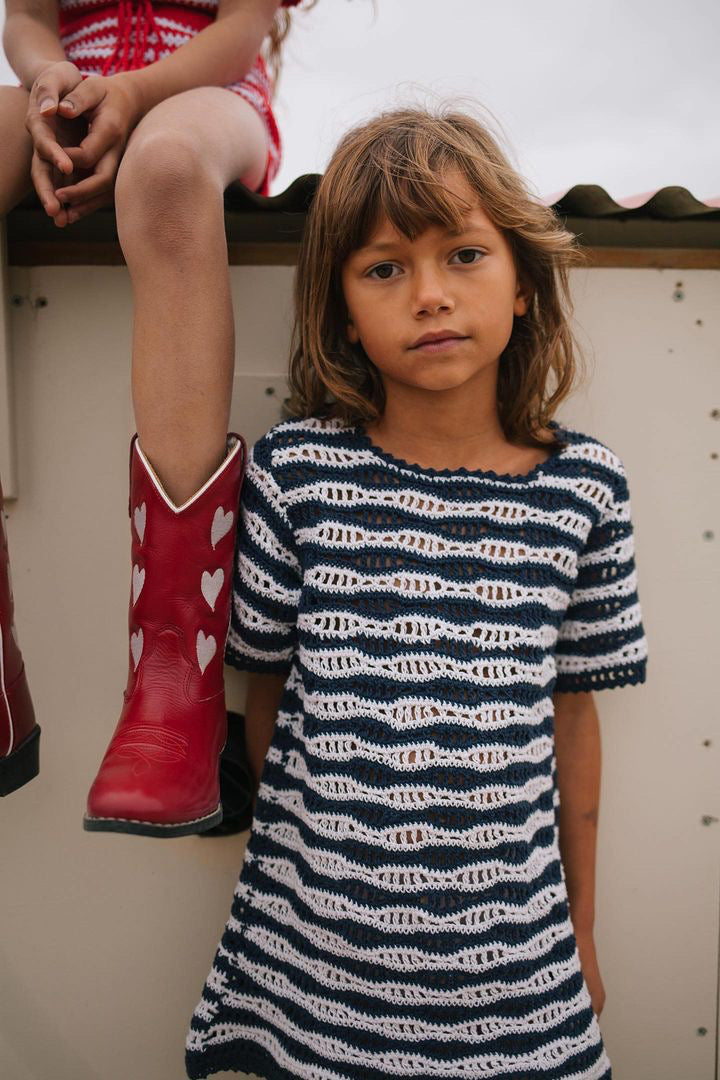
(0, 0), (314, 836)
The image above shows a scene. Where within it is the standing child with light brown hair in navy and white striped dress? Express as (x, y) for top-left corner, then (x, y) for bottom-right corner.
(187, 108), (648, 1080)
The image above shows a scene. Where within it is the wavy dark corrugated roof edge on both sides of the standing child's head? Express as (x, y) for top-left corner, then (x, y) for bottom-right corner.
(225, 173), (720, 221)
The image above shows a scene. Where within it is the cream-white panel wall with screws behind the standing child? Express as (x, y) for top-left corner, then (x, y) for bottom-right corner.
(0, 267), (720, 1080)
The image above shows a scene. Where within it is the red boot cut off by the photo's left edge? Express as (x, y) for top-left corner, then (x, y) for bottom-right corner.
(0, 473), (40, 795)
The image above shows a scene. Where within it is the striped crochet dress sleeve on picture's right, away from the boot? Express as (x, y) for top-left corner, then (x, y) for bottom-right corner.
(554, 459), (648, 692)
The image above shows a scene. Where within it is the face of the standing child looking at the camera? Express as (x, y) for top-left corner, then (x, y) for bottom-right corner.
(342, 172), (528, 391)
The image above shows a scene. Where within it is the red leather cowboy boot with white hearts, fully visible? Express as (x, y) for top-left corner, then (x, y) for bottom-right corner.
(83, 434), (246, 836)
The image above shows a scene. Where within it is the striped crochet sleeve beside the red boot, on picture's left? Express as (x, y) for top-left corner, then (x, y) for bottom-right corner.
(226, 435), (301, 673)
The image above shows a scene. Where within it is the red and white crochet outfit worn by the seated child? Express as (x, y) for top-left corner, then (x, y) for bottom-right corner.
(48, 0), (300, 195)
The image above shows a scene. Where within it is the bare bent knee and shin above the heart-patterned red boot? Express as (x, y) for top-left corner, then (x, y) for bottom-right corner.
(114, 86), (268, 505)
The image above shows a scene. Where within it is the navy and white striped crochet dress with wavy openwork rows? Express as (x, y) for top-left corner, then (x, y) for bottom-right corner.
(187, 418), (648, 1080)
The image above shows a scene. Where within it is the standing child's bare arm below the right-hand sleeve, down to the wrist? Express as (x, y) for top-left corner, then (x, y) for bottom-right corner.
(553, 691), (601, 934)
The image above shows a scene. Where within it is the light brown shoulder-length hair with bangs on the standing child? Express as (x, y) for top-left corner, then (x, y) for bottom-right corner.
(285, 105), (587, 448)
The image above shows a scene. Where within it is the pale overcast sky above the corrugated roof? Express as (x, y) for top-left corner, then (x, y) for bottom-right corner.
(0, 0), (720, 199)
